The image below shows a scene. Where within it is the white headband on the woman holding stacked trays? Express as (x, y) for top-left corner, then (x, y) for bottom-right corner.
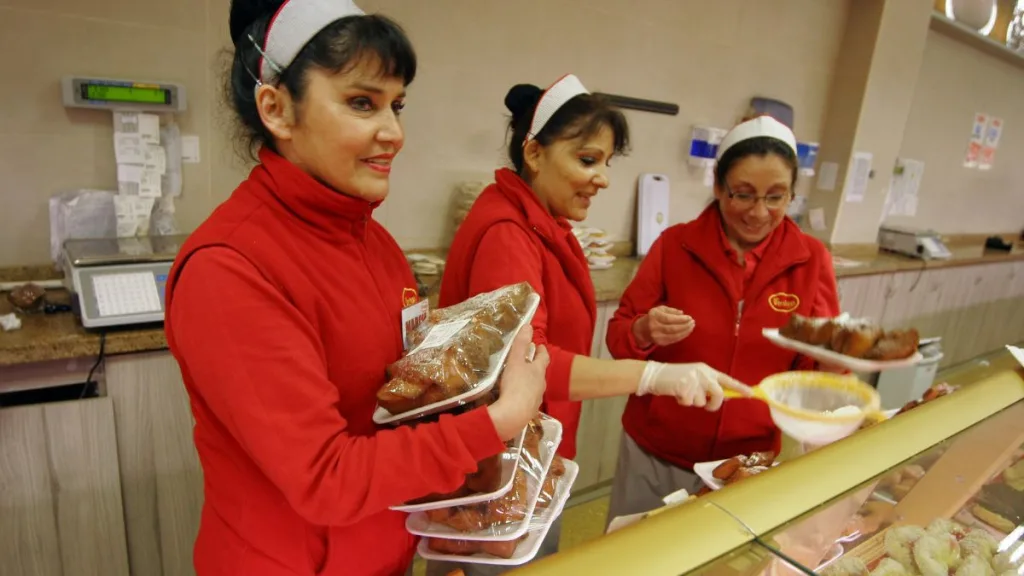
(256, 0), (366, 84)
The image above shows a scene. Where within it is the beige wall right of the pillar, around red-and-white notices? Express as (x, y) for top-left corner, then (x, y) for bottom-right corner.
(887, 32), (1024, 234)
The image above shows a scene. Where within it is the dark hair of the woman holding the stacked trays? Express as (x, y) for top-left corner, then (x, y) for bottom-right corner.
(225, 0), (416, 159)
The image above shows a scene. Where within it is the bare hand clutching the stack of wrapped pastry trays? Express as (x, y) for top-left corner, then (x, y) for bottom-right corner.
(487, 325), (551, 440)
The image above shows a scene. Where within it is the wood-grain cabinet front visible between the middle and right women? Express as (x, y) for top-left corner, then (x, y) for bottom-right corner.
(573, 301), (627, 492)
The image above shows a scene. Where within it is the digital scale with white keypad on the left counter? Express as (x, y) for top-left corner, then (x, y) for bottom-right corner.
(63, 236), (185, 328)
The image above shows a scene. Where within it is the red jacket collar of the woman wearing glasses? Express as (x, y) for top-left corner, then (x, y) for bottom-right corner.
(681, 202), (811, 300)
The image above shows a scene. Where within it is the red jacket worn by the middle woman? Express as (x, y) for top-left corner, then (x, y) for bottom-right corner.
(438, 168), (597, 459)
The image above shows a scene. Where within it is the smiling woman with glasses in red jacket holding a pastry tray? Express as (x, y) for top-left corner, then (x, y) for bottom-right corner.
(607, 116), (839, 519)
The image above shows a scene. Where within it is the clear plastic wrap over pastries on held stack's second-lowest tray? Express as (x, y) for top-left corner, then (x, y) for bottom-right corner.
(406, 414), (565, 541)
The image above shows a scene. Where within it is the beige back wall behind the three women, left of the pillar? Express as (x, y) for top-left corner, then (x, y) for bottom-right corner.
(0, 0), (848, 266)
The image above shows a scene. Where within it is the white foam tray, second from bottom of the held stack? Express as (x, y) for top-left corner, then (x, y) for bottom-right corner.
(406, 417), (562, 541)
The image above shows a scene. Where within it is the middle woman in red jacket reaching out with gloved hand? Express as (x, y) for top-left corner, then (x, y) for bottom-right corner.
(431, 75), (749, 574)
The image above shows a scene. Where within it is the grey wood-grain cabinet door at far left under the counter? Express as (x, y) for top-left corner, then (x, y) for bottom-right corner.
(0, 398), (129, 576)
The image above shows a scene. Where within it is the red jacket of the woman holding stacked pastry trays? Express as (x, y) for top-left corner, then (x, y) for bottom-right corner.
(166, 149), (504, 576)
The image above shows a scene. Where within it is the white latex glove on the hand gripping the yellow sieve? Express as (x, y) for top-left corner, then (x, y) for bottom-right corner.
(637, 362), (754, 412)
